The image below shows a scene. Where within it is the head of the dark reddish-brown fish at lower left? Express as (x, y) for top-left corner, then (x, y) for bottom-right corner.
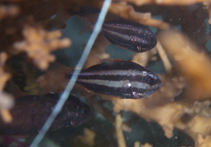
(64, 96), (91, 127)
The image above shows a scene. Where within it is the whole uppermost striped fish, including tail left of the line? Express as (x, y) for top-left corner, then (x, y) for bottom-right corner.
(66, 7), (157, 52)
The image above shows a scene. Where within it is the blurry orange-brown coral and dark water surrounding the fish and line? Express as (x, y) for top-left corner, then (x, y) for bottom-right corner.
(0, 0), (211, 147)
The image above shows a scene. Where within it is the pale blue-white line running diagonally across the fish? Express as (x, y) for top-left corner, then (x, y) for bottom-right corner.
(30, 0), (111, 147)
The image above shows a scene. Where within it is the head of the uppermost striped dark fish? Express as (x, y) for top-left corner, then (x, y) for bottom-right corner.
(136, 29), (157, 52)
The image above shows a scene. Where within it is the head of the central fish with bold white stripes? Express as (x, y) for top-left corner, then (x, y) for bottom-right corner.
(131, 72), (162, 99)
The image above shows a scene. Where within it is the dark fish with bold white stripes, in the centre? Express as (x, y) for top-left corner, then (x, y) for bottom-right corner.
(67, 61), (161, 99)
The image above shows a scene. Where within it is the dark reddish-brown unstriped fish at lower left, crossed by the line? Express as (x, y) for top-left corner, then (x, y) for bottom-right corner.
(0, 94), (91, 136)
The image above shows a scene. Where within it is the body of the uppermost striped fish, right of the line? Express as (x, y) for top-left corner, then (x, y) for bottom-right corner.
(102, 19), (157, 52)
